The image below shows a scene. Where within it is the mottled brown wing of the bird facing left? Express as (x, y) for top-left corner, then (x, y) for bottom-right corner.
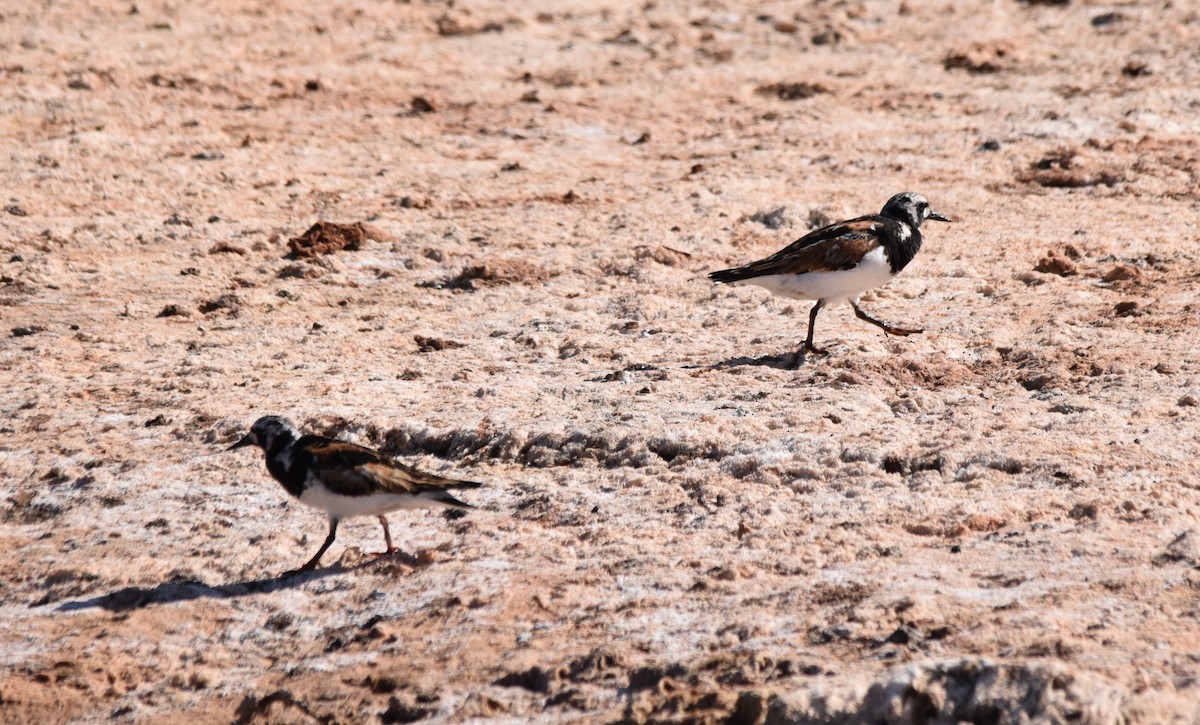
(300, 436), (480, 496)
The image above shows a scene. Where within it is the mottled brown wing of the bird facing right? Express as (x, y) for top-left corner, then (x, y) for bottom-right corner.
(709, 216), (883, 282)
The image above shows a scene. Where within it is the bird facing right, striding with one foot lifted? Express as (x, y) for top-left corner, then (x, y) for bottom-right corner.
(708, 191), (953, 354)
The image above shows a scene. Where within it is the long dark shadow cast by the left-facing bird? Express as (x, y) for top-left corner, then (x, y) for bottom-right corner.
(55, 564), (352, 612)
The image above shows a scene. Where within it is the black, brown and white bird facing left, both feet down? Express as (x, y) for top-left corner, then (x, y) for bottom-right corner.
(227, 415), (482, 574)
